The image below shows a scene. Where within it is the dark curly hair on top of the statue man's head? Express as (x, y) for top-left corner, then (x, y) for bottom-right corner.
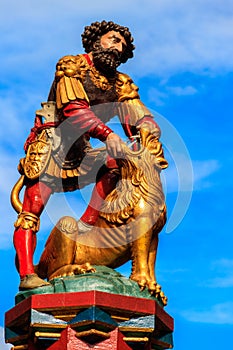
(82, 21), (135, 63)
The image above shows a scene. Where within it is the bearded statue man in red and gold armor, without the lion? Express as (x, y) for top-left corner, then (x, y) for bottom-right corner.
(12, 21), (160, 290)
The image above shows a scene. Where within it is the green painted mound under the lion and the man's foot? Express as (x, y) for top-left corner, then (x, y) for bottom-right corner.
(15, 266), (163, 306)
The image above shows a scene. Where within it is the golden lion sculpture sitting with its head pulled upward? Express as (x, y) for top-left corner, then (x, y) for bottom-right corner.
(37, 128), (168, 302)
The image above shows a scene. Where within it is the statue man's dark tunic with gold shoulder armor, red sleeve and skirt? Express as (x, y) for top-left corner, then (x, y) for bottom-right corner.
(23, 54), (158, 191)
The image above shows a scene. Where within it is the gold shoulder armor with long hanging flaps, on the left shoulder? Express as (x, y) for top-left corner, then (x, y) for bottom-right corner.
(55, 55), (89, 108)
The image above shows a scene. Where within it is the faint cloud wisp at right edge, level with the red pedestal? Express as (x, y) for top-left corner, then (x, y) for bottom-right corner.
(181, 302), (233, 325)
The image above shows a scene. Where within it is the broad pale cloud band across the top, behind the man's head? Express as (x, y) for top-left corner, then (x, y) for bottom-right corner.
(0, 0), (233, 78)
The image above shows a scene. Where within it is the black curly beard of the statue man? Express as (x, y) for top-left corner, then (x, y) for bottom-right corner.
(92, 43), (121, 77)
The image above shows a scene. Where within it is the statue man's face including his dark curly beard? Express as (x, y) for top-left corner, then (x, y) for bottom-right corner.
(92, 31), (126, 76)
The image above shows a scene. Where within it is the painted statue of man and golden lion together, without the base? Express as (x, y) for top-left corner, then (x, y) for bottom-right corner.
(11, 21), (167, 292)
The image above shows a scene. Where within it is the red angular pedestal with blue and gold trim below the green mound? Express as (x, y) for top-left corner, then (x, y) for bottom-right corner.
(5, 291), (173, 350)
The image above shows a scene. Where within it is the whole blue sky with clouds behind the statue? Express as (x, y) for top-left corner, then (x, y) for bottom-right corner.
(0, 0), (233, 350)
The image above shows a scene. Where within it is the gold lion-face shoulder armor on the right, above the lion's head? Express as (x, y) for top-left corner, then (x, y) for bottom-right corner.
(116, 73), (139, 102)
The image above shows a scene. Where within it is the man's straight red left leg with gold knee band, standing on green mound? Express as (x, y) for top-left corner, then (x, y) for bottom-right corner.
(14, 181), (52, 290)
